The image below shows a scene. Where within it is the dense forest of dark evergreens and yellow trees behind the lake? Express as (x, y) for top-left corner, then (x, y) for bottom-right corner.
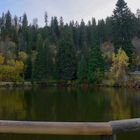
(0, 0), (140, 84)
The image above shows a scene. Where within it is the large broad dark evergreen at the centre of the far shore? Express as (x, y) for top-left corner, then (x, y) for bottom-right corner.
(56, 27), (77, 81)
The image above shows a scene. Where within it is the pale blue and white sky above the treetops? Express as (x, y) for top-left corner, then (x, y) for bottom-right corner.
(0, 0), (140, 26)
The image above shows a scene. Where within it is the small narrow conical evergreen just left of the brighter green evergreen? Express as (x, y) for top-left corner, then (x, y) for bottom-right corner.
(77, 56), (88, 82)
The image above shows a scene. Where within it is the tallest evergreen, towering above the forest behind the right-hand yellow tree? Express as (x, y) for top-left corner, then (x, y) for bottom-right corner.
(112, 0), (134, 62)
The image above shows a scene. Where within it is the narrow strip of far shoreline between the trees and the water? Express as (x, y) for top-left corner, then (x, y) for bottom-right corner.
(0, 81), (140, 89)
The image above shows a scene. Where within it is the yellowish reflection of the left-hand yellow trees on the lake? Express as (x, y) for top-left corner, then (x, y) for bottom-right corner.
(0, 90), (26, 120)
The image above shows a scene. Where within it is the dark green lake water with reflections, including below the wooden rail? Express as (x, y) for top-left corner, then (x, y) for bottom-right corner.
(0, 88), (140, 140)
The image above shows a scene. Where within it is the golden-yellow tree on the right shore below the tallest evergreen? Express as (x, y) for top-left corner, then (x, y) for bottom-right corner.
(110, 49), (129, 86)
